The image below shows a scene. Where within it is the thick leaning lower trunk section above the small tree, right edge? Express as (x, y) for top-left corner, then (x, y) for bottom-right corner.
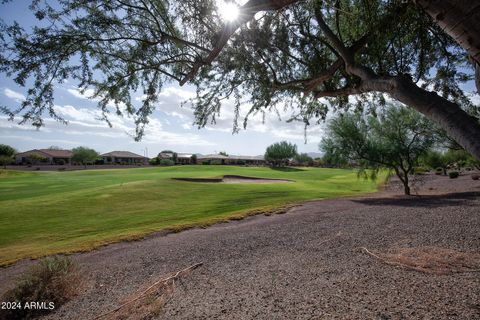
(374, 76), (480, 160)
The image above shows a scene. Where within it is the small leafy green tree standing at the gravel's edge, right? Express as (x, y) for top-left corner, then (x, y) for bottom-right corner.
(320, 106), (436, 195)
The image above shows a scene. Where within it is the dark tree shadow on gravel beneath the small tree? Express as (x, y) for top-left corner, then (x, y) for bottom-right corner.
(352, 191), (480, 208)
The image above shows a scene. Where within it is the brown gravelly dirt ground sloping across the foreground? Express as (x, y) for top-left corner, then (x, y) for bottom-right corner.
(0, 175), (480, 320)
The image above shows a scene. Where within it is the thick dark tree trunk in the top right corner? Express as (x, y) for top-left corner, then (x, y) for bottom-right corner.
(414, 0), (480, 92)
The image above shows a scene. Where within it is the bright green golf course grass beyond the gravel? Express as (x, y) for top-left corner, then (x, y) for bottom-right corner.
(0, 166), (377, 265)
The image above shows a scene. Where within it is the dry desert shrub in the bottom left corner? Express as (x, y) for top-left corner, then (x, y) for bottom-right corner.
(0, 256), (80, 319)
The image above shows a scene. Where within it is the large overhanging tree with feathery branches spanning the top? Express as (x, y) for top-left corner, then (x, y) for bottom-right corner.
(0, 0), (480, 159)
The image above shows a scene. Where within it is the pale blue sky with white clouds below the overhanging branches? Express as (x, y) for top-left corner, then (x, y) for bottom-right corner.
(0, 0), (322, 156)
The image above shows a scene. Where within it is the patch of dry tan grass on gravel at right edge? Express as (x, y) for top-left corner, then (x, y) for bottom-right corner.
(362, 247), (480, 275)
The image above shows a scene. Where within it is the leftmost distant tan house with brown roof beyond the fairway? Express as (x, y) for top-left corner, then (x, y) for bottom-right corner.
(15, 149), (73, 164)
